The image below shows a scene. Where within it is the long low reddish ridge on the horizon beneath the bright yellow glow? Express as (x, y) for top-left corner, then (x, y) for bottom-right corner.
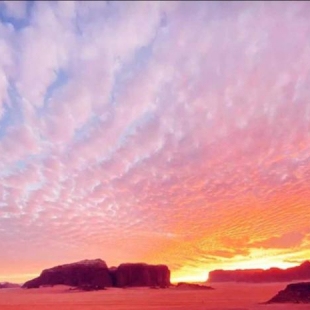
(208, 261), (310, 283)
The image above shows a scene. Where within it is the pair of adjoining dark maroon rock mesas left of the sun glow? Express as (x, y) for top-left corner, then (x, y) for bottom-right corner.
(23, 259), (170, 290)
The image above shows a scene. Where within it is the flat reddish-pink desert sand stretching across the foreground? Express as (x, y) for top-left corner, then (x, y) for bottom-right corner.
(0, 283), (310, 310)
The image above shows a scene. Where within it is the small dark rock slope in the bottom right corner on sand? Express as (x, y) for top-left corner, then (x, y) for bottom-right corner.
(267, 282), (310, 304)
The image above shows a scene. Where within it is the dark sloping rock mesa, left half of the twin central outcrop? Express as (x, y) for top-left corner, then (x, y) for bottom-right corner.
(22, 259), (113, 289)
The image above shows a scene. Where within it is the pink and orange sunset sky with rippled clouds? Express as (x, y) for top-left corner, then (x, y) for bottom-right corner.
(0, 1), (310, 282)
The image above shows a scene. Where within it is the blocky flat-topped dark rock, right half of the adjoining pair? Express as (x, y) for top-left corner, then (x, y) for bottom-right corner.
(112, 263), (170, 288)
